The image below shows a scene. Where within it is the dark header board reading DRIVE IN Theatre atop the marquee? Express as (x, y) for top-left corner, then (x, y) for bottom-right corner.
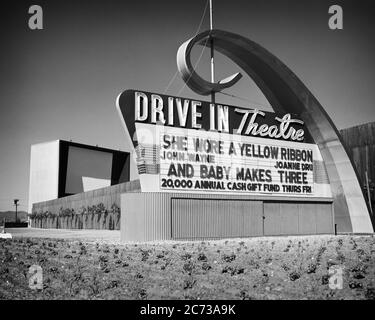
(118, 90), (312, 143)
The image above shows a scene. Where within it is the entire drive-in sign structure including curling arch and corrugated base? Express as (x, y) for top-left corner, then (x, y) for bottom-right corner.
(116, 30), (374, 241)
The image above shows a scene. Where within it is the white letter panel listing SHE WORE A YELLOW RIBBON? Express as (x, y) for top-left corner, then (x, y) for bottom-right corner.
(136, 123), (331, 197)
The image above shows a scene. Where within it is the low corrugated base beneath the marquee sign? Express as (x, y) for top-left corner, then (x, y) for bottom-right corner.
(121, 192), (335, 242)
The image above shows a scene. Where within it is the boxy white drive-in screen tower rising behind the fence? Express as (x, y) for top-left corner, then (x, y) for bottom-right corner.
(29, 140), (130, 212)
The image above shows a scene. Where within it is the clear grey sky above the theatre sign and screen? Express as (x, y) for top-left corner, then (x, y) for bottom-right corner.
(0, 0), (375, 211)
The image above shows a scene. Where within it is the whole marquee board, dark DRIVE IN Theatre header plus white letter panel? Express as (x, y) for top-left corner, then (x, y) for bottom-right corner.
(117, 90), (331, 197)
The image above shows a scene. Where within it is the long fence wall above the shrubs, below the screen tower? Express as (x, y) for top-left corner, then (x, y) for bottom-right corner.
(32, 180), (140, 214)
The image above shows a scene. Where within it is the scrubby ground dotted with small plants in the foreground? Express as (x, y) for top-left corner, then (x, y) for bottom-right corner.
(0, 232), (375, 299)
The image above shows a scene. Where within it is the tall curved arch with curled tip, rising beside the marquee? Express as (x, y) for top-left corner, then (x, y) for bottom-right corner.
(177, 30), (374, 233)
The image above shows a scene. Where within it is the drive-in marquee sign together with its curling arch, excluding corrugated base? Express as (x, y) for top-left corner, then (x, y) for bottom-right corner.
(116, 29), (374, 233)
